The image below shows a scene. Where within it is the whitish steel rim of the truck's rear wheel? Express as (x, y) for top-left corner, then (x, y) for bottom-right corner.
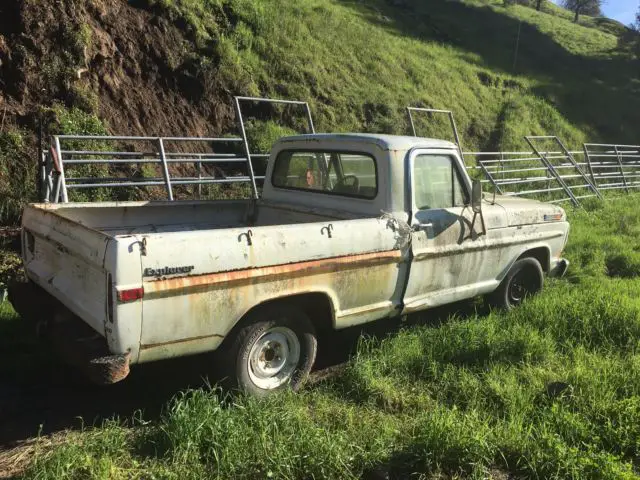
(248, 327), (300, 390)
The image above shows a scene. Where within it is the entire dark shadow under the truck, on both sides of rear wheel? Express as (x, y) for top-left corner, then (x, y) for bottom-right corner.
(0, 302), (484, 448)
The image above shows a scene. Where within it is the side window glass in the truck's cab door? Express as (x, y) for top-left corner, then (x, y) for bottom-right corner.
(412, 154), (466, 210)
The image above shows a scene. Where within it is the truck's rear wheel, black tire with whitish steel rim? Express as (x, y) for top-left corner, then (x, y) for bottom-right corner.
(223, 304), (318, 396)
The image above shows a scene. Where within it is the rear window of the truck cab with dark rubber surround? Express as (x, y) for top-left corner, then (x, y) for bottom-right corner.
(271, 150), (378, 199)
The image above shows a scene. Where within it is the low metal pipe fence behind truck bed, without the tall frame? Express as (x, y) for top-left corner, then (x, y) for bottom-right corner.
(41, 135), (252, 203)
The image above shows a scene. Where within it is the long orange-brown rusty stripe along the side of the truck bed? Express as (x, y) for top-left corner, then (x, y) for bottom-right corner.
(144, 250), (402, 298)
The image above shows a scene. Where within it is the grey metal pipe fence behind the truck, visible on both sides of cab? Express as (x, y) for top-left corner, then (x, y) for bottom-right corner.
(40, 96), (640, 205)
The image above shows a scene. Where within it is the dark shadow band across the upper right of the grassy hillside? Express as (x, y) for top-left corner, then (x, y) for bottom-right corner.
(343, 0), (640, 144)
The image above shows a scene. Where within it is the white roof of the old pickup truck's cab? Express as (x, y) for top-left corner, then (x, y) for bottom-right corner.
(279, 133), (458, 150)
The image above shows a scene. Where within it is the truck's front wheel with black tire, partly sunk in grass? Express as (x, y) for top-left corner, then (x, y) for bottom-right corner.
(487, 257), (544, 310)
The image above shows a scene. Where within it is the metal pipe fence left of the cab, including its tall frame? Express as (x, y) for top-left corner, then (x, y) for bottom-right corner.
(39, 97), (315, 203)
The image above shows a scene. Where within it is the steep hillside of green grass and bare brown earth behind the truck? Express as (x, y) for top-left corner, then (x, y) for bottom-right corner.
(0, 0), (640, 222)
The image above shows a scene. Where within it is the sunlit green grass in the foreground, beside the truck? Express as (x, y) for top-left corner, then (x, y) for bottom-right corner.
(18, 196), (640, 480)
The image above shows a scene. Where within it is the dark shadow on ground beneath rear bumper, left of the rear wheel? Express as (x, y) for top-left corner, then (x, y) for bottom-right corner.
(0, 318), (211, 449)
